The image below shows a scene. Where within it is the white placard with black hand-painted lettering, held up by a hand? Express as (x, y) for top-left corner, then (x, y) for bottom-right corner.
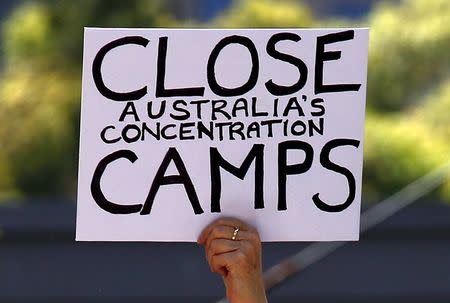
(76, 28), (368, 241)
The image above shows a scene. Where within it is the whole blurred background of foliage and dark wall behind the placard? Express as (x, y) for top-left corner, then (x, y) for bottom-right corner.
(0, 0), (450, 303)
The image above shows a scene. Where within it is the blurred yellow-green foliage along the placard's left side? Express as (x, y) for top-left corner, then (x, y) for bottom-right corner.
(0, 0), (174, 197)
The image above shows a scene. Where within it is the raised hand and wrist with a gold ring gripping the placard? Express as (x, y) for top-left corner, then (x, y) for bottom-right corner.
(198, 218), (267, 303)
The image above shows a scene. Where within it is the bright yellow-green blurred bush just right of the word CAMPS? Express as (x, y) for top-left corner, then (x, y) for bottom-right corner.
(363, 113), (450, 202)
